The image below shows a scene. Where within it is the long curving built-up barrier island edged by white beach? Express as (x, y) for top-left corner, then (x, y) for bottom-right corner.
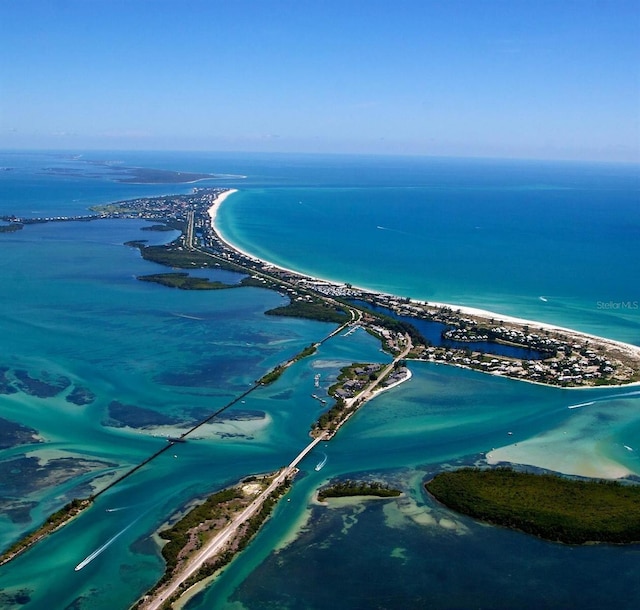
(6, 188), (640, 387)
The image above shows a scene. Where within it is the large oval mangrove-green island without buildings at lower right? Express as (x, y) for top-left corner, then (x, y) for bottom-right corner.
(425, 468), (640, 544)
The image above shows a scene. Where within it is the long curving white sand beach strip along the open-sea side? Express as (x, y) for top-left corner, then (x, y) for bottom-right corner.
(209, 189), (640, 364)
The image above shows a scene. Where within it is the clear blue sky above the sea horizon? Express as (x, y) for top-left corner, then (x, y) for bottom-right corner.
(0, 0), (640, 162)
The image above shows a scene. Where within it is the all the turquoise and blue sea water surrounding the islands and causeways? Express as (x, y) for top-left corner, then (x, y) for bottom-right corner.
(0, 148), (640, 610)
